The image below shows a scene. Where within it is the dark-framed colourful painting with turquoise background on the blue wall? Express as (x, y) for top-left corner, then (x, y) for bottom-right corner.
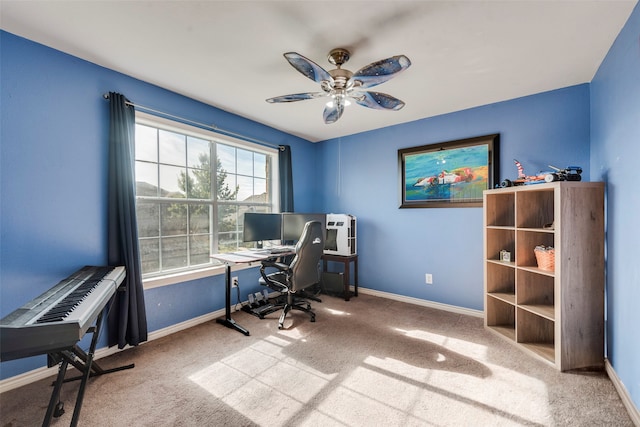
(398, 134), (500, 208)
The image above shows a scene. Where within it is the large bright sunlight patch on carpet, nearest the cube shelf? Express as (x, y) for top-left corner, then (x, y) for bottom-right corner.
(340, 356), (550, 426)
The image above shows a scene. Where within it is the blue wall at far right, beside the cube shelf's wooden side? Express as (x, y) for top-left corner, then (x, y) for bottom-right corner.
(591, 5), (640, 407)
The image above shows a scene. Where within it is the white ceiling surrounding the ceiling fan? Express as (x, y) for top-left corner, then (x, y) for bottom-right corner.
(0, 0), (637, 142)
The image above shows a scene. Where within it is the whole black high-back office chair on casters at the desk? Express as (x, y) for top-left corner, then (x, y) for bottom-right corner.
(260, 221), (324, 329)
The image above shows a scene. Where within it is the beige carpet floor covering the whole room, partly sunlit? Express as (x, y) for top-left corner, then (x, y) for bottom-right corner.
(0, 293), (633, 427)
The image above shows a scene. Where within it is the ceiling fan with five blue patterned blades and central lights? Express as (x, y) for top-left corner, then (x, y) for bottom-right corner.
(267, 48), (411, 124)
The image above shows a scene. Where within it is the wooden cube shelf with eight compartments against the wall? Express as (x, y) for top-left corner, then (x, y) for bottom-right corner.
(484, 182), (604, 371)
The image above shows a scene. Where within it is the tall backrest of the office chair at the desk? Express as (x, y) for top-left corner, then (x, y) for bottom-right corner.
(289, 221), (324, 292)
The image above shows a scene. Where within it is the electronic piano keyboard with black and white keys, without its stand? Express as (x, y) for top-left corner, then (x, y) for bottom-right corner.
(0, 266), (126, 362)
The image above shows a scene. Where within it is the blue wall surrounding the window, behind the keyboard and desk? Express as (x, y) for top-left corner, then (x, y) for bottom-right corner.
(0, 32), (320, 379)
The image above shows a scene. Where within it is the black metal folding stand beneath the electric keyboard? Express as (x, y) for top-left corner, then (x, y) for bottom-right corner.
(42, 310), (135, 427)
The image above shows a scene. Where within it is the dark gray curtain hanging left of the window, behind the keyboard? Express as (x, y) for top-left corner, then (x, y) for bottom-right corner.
(108, 92), (147, 348)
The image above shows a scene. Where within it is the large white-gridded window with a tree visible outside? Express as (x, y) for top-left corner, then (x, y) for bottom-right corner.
(135, 112), (278, 278)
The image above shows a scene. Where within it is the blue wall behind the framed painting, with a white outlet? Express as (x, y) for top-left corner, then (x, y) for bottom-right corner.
(322, 84), (589, 310)
